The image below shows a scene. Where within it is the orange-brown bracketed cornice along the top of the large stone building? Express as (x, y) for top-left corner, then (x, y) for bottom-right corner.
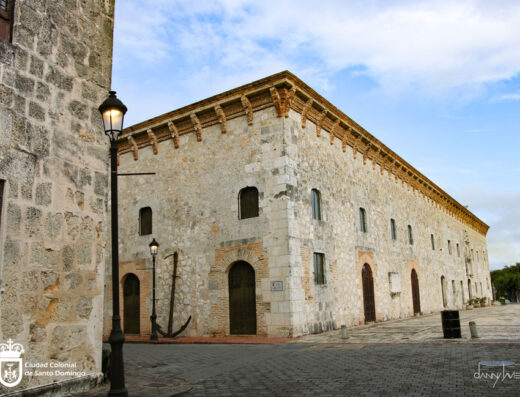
(119, 71), (489, 236)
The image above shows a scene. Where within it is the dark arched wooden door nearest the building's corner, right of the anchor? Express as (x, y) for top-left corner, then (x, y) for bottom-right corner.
(228, 261), (256, 335)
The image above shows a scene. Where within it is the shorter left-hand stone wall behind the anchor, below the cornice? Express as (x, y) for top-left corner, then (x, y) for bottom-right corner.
(108, 108), (291, 336)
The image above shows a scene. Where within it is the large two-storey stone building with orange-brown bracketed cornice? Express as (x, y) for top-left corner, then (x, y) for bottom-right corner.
(108, 72), (491, 336)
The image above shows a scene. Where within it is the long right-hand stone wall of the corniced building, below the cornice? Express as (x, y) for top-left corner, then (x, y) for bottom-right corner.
(284, 111), (492, 335)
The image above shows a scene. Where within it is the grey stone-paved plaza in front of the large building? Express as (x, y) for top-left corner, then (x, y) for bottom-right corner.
(72, 305), (520, 396)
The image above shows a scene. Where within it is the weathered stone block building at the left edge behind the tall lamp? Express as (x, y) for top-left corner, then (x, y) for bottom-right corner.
(0, 0), (114, 395)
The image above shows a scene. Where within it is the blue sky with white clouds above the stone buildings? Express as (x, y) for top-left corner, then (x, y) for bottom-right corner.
(112, 0), (520, 269)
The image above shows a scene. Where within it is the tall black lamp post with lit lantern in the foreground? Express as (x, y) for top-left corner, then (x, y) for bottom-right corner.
(99, 91), (128, 397)
